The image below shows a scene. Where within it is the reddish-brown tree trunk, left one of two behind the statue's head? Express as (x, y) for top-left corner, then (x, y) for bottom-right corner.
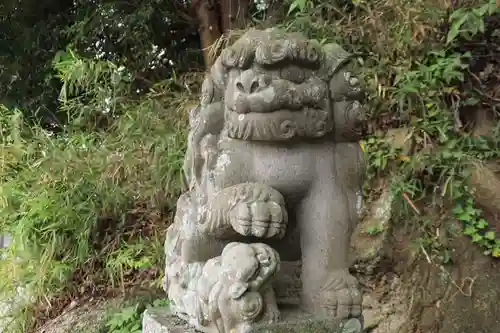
(193, 0), (221, 69)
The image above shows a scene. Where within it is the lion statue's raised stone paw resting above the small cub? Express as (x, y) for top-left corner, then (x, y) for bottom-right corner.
(230, 200), (288, 238)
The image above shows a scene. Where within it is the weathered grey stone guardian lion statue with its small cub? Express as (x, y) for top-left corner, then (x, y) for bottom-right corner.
(165, 29), (363, 333)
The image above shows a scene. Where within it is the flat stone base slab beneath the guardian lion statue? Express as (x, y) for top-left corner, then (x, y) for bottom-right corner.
(142, 307), (363, 333)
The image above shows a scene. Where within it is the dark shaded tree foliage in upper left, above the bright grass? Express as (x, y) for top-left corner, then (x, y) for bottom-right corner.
(0, 0), (202, 123)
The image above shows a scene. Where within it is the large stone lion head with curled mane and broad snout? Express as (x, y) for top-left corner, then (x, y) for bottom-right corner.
(201, 29), (363, 141)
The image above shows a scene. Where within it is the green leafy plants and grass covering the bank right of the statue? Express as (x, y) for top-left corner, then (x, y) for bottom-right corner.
(284, 0), (500, 262)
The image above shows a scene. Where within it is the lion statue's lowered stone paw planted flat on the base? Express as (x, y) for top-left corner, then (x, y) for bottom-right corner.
(314, 270), (363, 319)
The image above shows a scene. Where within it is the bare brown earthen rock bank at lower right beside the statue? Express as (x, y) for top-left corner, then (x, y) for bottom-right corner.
(351, 127), (500, 333)
